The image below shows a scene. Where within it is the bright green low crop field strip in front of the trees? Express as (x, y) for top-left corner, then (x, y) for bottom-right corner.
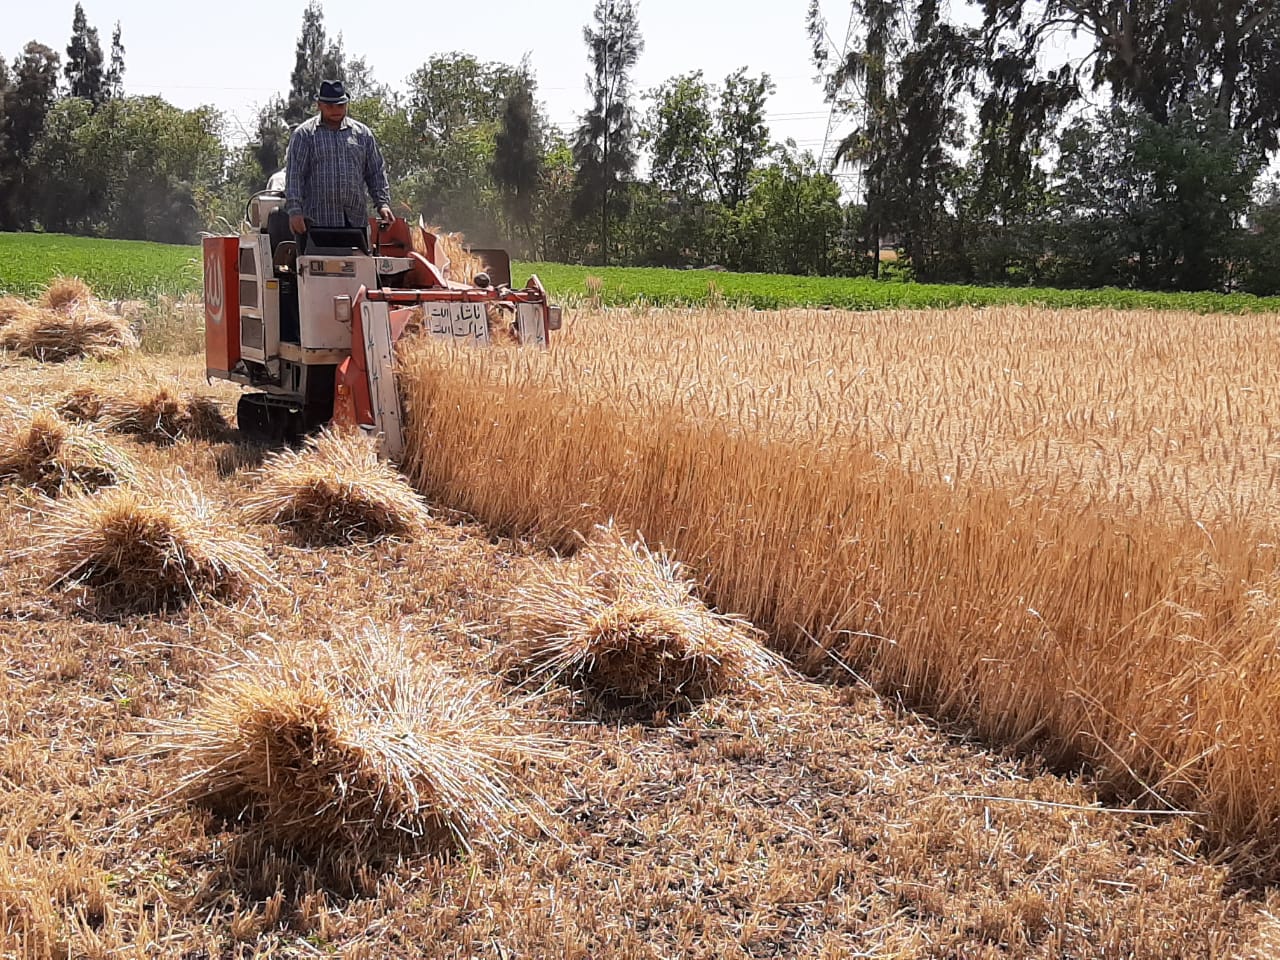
(0, 233), (1280, 314)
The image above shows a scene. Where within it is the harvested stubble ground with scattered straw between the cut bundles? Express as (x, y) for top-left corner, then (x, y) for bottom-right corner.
(0, 357), (1280, 960)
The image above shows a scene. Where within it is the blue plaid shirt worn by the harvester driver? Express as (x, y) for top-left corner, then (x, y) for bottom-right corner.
(284, 114), (392, 227)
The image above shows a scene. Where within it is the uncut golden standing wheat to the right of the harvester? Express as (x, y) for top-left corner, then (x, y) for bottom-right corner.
(404, 308), (1280, 876)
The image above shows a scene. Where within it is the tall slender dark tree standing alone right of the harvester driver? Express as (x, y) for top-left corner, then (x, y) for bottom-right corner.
(573, 0), (644, 265)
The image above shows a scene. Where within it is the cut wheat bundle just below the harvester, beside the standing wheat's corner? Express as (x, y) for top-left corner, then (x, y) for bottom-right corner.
(243, 430), (430, 545)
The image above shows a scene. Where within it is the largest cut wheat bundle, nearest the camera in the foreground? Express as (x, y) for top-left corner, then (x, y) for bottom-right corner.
(146, 627), (548, 854)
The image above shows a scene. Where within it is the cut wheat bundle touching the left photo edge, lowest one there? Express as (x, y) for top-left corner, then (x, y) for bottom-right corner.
(0, 410), (137, 497)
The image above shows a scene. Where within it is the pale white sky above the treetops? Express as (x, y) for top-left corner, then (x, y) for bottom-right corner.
(0, 0), (849, 167)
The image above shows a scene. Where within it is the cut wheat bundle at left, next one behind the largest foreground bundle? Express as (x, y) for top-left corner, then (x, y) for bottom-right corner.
(29, 477), (268, 613)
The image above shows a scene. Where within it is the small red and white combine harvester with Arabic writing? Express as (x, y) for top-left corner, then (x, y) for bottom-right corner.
(204, 192), (561, 461)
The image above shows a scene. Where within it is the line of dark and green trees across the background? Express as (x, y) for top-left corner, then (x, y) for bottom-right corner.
(0, 0), (1280, 293)
